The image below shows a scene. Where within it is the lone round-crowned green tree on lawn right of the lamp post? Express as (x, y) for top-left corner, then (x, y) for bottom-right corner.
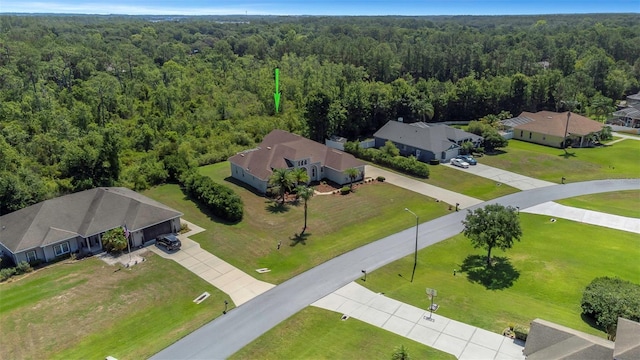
(462, 204), (522, 266)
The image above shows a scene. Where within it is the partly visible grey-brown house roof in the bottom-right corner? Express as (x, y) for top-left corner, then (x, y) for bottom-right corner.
(522, 318), (640, 360)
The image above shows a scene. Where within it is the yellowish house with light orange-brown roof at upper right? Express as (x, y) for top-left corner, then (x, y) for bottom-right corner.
(501, 111), (605, 148)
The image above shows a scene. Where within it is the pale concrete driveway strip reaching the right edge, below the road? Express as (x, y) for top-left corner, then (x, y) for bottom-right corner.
(520, 201), (640, 234)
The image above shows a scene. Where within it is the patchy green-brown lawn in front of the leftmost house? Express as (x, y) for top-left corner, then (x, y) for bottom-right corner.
(0, 253), (228, 359)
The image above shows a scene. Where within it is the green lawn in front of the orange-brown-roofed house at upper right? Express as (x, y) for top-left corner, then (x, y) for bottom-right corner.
(481, 140), (640, 183)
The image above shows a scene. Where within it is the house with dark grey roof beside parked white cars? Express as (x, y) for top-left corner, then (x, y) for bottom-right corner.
(373, 120), (483, 162)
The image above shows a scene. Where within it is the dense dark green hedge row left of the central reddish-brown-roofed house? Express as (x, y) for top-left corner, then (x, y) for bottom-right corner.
(182, 172), (244, 222)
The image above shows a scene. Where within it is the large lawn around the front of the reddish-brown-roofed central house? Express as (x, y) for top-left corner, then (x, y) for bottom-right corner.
(145, 162), (449, 284)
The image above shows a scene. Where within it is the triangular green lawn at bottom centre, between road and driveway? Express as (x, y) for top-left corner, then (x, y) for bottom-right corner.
(230, 307), (455, 360)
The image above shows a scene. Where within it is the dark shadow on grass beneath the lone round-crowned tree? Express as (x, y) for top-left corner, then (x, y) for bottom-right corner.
(460, 255), (520, 290)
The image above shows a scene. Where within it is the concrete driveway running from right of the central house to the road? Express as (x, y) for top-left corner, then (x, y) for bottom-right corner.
(365, 165), (483, 209)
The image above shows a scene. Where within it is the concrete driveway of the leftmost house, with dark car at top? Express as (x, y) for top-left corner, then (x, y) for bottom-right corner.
(148, 220), (275, 306)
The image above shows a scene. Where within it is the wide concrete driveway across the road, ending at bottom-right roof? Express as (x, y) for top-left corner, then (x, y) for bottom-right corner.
(311, 282), (524, 360)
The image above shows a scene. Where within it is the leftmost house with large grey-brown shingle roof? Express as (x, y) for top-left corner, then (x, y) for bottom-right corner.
(0, 187), (182, 264)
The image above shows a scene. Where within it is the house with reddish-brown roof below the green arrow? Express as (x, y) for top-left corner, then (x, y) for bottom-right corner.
(229, 130), (364, 194)
